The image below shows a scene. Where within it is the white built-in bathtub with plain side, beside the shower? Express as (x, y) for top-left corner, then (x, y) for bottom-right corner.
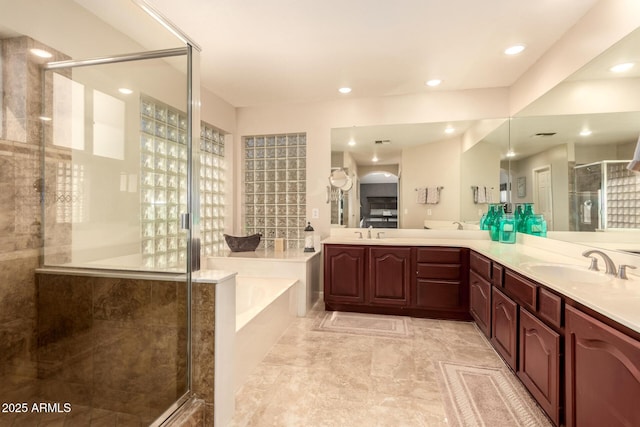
(234, 276), (298, 391)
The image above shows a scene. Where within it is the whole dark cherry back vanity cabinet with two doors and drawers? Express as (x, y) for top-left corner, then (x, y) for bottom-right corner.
(323, 244), (464, 320)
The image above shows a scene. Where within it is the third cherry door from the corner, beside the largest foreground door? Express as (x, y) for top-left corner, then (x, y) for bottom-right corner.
(518, 308), (560, 425)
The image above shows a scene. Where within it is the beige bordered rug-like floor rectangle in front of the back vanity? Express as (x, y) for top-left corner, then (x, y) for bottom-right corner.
(313, 311), (413, 338)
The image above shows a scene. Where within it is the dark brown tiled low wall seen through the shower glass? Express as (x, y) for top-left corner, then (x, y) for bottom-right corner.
(37, 270), (187, 425)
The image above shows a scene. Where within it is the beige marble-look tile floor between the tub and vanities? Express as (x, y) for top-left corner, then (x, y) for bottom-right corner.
(232, 305), (551, 427)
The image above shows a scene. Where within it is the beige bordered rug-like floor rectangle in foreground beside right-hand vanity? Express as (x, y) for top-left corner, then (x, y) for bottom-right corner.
(439, 362), (552, 427)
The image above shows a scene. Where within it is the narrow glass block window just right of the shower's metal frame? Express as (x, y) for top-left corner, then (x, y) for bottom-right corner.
(200, 123), (225, 255)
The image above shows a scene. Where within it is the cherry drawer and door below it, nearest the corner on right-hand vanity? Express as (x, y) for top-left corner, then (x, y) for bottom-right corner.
(469, 252), (494, 338)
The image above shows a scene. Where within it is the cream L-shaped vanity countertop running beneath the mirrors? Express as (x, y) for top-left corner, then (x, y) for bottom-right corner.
(322, 230), (640, 332)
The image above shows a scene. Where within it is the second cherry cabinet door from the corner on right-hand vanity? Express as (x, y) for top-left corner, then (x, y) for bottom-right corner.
(491, 288), (518, 371)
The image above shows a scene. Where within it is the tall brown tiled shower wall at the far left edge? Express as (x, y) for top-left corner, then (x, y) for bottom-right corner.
(0, 37), (67, 401)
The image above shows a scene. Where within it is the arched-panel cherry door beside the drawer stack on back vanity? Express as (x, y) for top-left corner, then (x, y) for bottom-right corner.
(368, 247), (411, 306)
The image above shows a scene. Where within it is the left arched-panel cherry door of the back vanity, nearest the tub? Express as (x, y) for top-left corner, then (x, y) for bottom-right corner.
(323, 245), (366, 304)
